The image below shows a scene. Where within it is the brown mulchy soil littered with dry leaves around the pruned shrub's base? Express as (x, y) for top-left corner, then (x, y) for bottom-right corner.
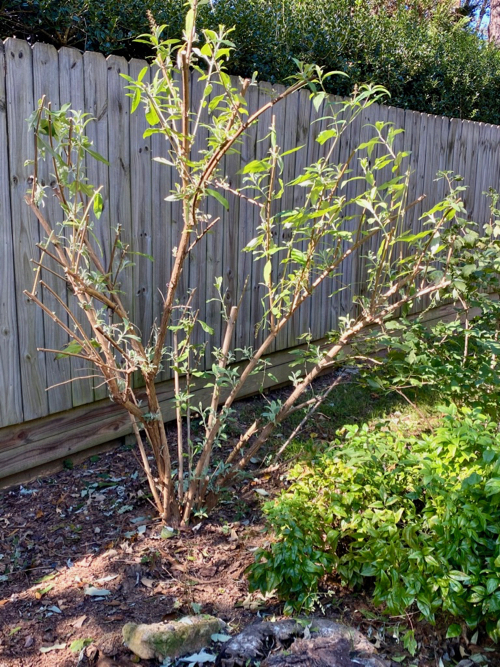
(0, 390), (500, 667)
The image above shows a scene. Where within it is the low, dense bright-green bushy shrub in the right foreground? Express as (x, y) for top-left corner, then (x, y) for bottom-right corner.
(251, 406), (500, 639)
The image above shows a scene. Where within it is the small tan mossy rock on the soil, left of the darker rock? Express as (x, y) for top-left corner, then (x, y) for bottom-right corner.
(122, 614), (225, 660)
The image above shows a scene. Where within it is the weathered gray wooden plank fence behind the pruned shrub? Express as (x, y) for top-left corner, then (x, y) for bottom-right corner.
(0, 39), (500, 477)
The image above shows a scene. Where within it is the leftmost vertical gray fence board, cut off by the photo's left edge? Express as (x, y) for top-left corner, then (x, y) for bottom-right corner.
(0, 42), (23, 426)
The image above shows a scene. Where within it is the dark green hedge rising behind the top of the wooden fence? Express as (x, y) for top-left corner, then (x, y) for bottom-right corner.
(0, 0), (500, 124)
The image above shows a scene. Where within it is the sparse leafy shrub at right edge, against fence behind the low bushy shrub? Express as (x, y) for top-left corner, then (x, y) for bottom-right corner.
(363, 187), (500, 418)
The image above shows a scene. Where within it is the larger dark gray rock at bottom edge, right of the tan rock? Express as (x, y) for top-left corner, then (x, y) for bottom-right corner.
(218, 618), (389, 667)
